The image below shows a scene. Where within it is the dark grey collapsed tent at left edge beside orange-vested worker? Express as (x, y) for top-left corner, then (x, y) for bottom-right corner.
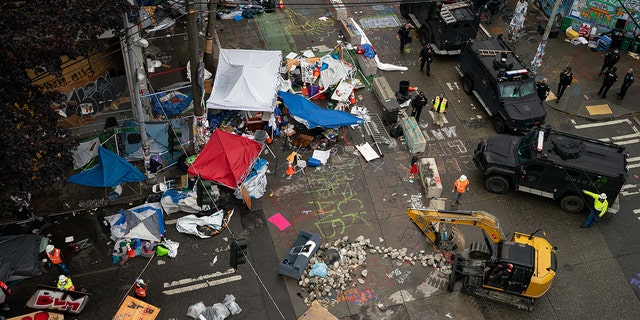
(0, 234), (42, 282)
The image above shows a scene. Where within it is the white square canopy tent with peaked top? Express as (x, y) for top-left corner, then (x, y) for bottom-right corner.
(207, 49), (282, 112)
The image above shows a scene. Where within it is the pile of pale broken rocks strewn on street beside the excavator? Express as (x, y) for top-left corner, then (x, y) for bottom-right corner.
(298, 236), (451, 306)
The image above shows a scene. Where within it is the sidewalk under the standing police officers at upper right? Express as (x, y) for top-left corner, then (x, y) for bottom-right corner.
(482, 0), (640, 120)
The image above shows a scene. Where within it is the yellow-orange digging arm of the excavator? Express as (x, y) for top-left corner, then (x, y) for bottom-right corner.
(407, 208), (504, 244)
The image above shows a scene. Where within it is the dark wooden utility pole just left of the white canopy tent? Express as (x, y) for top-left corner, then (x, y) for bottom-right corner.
(185, 0), (207, 153)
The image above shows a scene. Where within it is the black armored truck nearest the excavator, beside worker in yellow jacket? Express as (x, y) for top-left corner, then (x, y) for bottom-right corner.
(473, 126), (628, 213)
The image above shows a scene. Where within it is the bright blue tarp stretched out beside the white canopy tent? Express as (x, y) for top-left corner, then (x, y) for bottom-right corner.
(278, 91), (364, 129)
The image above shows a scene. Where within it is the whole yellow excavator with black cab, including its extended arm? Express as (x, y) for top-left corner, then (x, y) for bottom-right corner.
(407, 208), (557, 310)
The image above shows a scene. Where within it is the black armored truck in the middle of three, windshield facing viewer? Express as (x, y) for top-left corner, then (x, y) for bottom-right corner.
(456, 36), (547, 134)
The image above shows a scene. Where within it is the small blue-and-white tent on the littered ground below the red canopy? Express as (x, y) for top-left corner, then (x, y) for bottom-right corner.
(105, 202), (164, 242)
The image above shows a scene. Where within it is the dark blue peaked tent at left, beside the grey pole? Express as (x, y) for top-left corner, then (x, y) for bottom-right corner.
(67, 147), (146, 187)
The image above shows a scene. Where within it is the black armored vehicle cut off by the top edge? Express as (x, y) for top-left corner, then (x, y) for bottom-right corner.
(400, 0), (480, 55)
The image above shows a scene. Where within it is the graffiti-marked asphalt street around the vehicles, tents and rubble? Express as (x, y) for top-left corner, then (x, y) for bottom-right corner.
(6, 0), (640, 319)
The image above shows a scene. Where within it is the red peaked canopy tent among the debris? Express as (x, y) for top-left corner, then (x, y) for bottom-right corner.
(188, 129), (262, 189)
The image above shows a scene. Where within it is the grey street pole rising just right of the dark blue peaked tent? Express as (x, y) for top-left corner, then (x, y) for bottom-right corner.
(120, 13), (154, 179)
